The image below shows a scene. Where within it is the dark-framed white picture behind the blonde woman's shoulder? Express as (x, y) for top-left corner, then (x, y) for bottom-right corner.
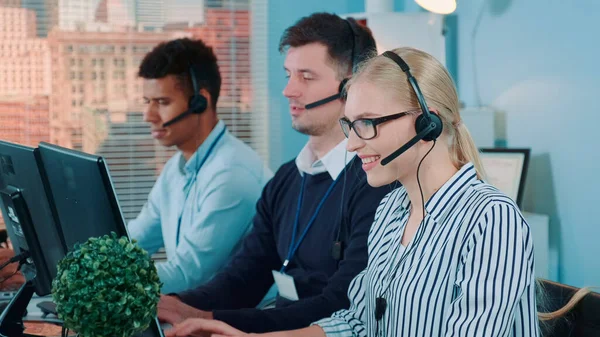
(479, 148), (530, 208)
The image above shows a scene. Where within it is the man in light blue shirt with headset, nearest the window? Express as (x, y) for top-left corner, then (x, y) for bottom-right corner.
(128, 38), (272, 293)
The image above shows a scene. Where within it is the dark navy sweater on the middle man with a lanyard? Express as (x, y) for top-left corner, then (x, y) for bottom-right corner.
(178, 157), (395, 333)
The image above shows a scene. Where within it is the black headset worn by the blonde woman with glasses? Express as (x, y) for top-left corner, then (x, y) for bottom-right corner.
(381, 51), (443, 165)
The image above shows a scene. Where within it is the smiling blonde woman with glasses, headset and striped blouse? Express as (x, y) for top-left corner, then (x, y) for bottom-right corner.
(168, 48), (556, 337)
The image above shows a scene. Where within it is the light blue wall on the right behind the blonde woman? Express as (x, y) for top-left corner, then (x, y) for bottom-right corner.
(452, 0), (600, 286)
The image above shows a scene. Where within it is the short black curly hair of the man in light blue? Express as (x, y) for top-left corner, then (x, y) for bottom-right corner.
(138, 38), (221, 108)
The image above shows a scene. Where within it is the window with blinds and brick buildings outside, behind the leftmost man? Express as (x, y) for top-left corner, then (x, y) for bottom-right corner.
(0, 0), (270, 236)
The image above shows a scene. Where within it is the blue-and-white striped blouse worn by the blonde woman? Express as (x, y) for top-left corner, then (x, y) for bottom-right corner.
(315, 163), (539, 337)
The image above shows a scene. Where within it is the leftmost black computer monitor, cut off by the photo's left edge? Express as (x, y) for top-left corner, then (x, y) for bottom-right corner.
(0, 141), (66, 296)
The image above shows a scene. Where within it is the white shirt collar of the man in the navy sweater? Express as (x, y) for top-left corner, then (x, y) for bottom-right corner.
(296, 139), (356, 180)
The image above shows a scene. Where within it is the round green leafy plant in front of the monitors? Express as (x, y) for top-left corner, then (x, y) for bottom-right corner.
(52, 233), (162, 337)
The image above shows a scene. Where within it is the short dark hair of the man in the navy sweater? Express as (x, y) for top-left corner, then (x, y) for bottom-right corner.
(279, 13), (376, 78)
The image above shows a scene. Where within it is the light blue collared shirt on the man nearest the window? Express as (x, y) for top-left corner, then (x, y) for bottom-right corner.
(128, 121), (273, 293)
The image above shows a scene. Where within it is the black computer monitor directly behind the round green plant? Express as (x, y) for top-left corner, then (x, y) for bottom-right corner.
(39, 142), (162, 337)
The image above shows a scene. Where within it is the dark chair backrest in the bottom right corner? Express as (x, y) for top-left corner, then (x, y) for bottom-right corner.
(541, 280), (600, 337)
